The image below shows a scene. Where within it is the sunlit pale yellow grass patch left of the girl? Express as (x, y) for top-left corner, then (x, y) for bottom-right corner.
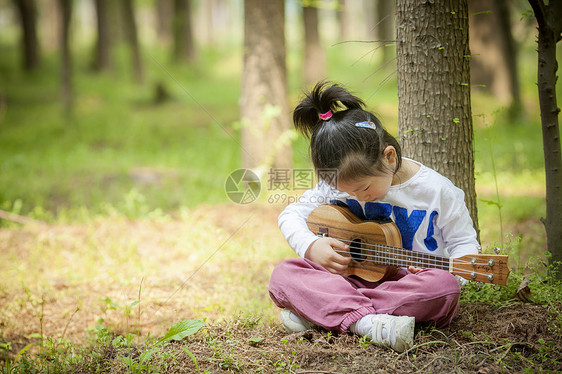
(0, 205), (287, 339)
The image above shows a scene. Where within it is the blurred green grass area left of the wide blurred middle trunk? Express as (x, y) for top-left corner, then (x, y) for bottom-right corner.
(0, 43), (245, 219)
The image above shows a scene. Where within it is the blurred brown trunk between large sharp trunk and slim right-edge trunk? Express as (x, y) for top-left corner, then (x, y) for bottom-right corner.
(469, 0), (521, 115)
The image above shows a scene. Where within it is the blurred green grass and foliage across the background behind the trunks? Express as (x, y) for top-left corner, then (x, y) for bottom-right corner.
(0, 2), (562, 254)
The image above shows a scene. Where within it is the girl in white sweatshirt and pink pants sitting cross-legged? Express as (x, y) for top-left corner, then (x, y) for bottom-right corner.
(269, 82), (479, 352)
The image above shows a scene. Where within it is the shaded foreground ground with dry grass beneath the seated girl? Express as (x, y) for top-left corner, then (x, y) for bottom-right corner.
(73, 303), (562, 374)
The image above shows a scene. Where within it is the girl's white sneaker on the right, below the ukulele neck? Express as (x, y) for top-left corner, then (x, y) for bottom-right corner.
(370, 314), (416, 352)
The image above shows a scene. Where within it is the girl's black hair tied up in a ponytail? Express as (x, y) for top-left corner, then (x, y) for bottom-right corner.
(293, 81), (402, 186)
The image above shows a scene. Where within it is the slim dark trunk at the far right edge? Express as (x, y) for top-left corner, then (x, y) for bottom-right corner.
(529, 0), (562, 279)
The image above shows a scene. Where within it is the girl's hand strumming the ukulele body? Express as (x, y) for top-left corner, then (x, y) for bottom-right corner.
(304, 238), (351, 274)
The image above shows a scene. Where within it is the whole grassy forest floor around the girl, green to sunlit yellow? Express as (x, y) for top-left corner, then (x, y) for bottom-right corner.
(0, 11), (562, 373)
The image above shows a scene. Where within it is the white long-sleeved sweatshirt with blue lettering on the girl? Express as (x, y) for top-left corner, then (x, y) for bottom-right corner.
(279, 161), (480, 257)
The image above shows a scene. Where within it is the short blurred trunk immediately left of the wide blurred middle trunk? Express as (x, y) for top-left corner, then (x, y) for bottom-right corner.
(174, 0), (195, 62)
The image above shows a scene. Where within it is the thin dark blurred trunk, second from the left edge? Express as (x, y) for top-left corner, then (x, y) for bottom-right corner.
(59, 0), (73, 118)
